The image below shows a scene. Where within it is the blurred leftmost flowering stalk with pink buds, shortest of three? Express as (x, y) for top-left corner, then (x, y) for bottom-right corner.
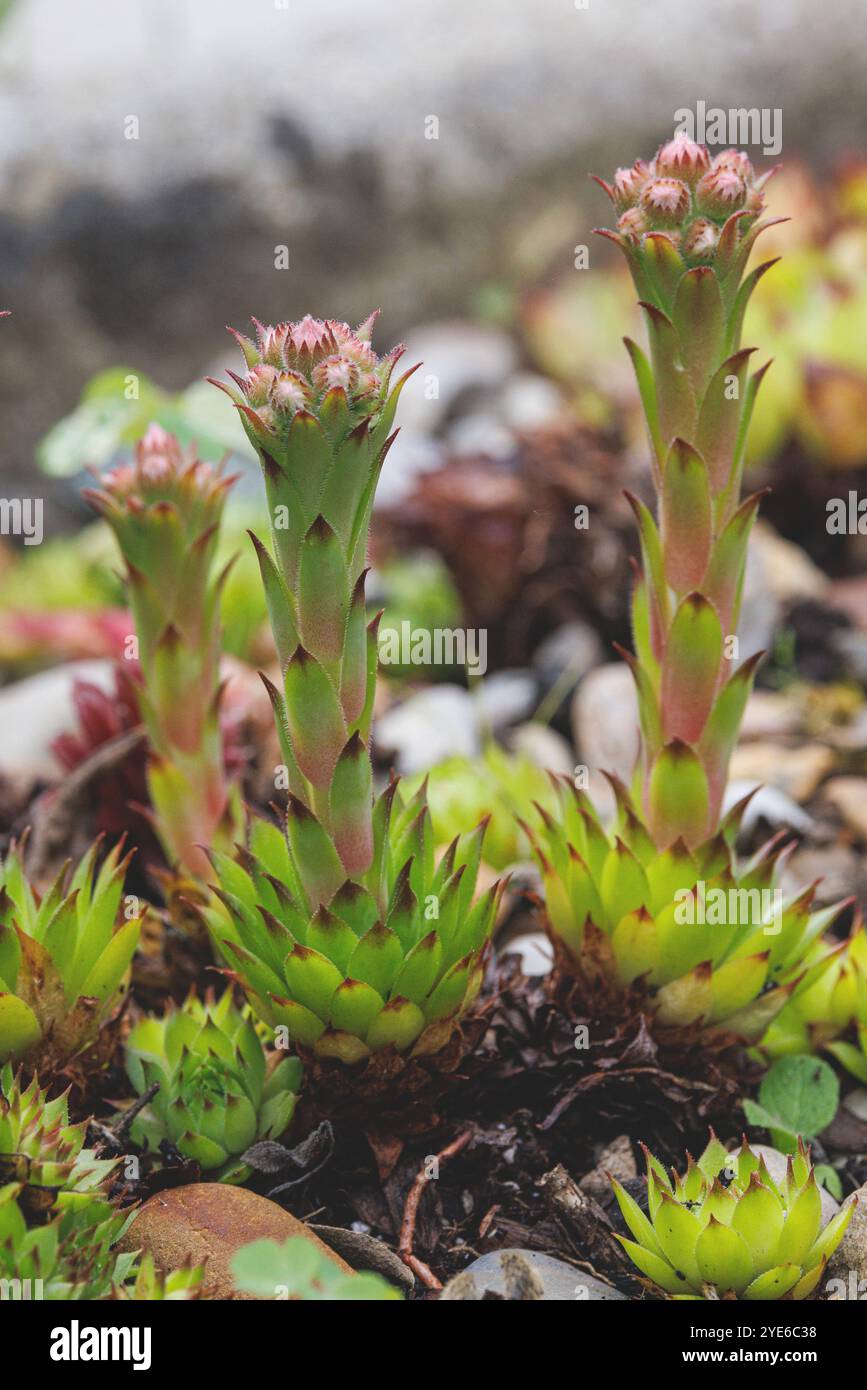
(85, 425), (240, 877)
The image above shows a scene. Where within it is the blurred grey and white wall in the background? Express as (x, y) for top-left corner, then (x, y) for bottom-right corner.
(0, 0), (867, 477)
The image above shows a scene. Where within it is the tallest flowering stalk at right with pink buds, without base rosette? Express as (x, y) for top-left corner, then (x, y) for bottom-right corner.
(591, 138), (779, 849)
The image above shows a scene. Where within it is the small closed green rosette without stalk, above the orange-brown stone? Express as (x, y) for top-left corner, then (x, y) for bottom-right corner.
(126, 990), (302, 1182)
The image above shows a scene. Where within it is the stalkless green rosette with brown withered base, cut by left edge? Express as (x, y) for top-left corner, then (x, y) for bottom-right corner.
(0, 840), (142, 1070)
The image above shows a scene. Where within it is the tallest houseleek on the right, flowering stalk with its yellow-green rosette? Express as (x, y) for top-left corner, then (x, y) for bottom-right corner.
(534, 138), (850, 1038)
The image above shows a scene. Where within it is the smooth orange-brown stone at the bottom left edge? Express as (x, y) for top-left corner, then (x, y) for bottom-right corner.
(118, 1183), (354, 1300)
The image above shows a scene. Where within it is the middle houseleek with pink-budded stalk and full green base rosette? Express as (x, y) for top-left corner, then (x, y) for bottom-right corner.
(206, 316), (497, 1063)
